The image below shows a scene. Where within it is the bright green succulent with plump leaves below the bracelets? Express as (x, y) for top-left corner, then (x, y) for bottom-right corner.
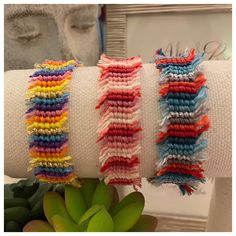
(23, 179), (157, 232)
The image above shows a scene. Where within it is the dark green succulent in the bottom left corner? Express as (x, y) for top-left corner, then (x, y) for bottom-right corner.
(4, 178), (64, 232)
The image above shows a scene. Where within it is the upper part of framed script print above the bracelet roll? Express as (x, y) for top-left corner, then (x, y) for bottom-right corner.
(106, 4), (232, 62)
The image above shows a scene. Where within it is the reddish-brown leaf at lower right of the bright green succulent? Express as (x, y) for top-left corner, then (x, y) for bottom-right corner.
(129, 215), (157, 232)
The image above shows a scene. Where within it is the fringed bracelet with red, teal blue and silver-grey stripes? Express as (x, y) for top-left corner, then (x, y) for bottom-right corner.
(149, 49), (209, 195)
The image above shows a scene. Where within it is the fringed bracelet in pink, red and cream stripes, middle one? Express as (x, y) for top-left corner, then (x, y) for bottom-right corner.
(96, 55), (142, 189)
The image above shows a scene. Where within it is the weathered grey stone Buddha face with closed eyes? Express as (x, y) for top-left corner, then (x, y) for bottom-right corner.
(4, 4), (99, 70)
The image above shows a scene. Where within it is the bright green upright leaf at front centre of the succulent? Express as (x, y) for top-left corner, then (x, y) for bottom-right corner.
(87, 208), (114, 232)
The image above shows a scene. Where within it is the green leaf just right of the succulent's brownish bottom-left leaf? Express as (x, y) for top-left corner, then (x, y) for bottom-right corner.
(52, 215), (80, 232)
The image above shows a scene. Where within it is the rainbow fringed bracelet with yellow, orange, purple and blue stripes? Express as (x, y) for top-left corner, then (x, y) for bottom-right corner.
(26, 60), (81, 186)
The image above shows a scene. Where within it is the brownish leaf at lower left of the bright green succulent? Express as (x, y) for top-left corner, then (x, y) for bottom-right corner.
(23, 220), (54, 232)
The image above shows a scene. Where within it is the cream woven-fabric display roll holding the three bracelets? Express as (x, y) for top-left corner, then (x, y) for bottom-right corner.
(4, 61), (232, 177)
